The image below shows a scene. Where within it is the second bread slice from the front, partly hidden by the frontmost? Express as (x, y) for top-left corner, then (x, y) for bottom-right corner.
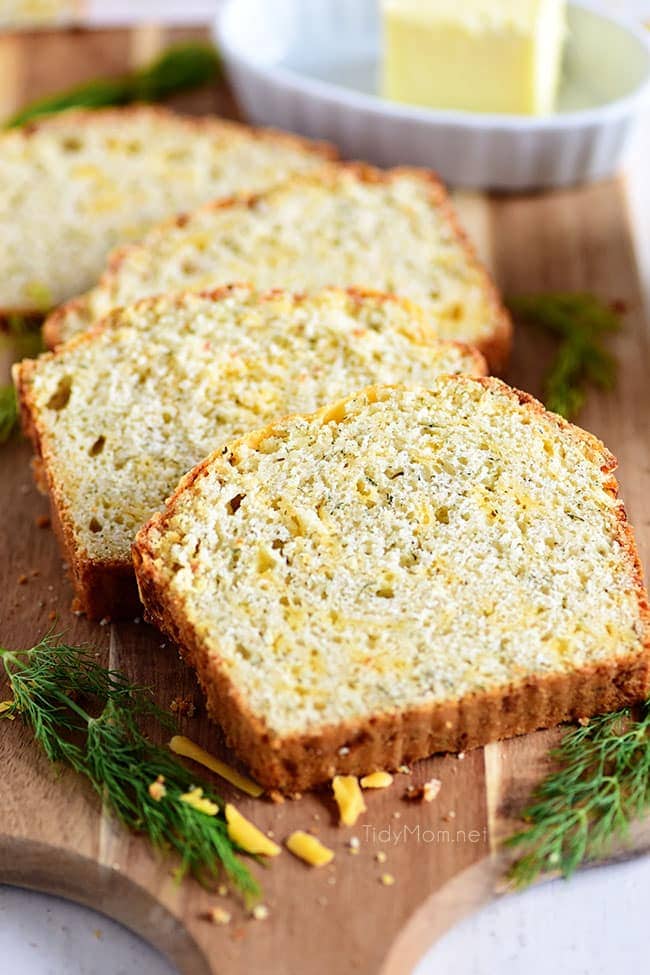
(15, 286), (485, 618)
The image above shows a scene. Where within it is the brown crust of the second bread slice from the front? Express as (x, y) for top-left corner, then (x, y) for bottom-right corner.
(12, 283), (487, 620)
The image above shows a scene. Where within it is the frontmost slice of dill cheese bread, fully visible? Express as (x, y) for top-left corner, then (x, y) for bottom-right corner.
(134, 376), (650, 791)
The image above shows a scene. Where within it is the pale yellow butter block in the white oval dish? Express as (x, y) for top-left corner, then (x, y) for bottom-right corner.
(382, 0), (566, 115)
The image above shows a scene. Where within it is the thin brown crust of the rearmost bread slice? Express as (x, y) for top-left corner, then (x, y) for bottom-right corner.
(0, 104), (338, 320)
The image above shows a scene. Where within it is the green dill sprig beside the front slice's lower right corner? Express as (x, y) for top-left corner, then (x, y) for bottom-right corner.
(506, 700), (650, 887)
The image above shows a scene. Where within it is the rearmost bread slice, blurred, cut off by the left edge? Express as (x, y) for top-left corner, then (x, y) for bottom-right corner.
(0, 107), (333, 315)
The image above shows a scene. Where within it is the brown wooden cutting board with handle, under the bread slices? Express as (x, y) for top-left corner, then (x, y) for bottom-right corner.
(0, 21), (650, 975)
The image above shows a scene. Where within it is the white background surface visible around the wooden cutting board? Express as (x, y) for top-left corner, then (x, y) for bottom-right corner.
(0, 0), (650, 975)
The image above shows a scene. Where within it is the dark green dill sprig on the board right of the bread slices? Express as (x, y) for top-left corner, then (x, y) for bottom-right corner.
(506, 292), (621, 419)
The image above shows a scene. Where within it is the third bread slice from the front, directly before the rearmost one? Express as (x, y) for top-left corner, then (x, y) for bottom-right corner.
(45, 164), (511, 371)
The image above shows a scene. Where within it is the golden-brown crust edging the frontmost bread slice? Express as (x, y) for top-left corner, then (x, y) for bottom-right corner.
(133, 376), (650, 792)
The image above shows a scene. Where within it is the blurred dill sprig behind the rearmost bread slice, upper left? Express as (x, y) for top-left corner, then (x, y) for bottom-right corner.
(5, 42), (221, 129)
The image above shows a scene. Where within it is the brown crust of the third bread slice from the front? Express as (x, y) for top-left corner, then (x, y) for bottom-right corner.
(43, 162), (513, 374)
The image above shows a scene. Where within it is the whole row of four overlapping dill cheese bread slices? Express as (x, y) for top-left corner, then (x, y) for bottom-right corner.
(12, 110), (650, 790)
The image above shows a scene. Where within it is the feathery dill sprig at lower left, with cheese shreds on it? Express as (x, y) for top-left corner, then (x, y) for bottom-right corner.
(0, 634), (259, 900)
